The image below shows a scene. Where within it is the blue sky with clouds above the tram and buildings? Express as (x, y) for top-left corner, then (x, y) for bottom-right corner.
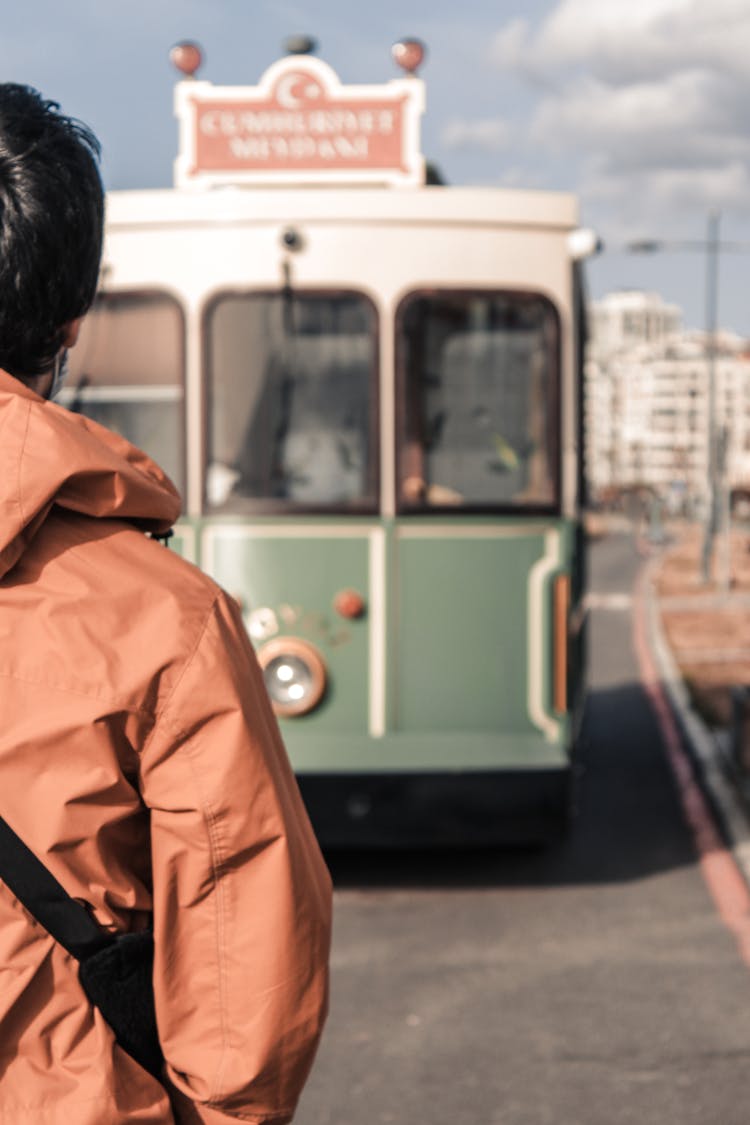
(0, 0), (750, 336)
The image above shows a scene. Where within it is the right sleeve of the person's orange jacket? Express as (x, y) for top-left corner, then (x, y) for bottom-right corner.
(142, 594), (331, 1125)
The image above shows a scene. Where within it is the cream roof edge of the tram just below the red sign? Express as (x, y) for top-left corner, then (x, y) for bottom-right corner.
(107, 187), (579, 231)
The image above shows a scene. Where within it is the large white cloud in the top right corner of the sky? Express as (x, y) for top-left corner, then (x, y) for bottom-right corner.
(489, 0), (750, 222)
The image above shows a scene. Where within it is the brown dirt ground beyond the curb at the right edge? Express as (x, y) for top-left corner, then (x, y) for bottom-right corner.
(656, 525), (750, 727)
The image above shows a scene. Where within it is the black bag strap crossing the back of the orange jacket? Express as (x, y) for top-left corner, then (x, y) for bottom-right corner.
(0, 817), (114, 961)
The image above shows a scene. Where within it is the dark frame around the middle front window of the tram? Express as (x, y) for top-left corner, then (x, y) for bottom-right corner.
(200, 285), (381, 518)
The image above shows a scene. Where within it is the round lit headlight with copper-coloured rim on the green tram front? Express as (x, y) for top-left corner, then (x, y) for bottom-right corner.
(257, 637), (326, 718)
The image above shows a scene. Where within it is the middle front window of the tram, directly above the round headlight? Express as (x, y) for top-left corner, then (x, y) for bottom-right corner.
(206, 293), (377, 512)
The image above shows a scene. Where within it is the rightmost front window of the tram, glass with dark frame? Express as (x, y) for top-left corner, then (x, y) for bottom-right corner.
(398, 293), (559, 510)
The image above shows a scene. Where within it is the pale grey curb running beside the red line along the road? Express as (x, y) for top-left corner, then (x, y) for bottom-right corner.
(644, 556), (750, 885)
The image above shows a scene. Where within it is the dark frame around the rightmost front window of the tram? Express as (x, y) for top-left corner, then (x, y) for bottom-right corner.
(394, 286), (562, 518)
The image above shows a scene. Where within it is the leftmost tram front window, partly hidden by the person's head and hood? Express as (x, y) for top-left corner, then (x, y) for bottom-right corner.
(66, 293), (184, 494)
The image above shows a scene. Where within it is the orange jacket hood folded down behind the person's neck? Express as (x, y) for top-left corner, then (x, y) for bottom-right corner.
(0, 370), (181, 578)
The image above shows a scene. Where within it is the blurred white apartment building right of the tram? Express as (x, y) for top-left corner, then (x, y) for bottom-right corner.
(586, 293), (750, 504)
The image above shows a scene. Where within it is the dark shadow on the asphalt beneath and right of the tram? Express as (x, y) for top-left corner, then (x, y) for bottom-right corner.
(326, 683), (695, 889)
